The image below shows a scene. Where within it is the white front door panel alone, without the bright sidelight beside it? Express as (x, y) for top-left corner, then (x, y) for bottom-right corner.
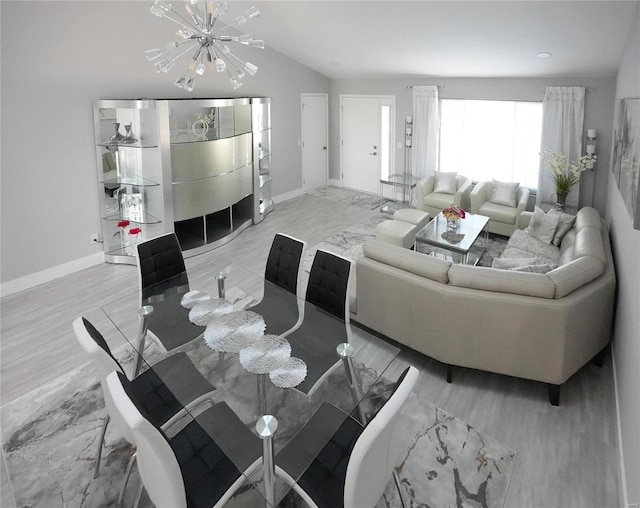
(341, 97), (380, 194)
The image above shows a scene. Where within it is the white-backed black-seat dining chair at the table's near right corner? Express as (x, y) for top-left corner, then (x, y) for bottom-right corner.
(276, 366), (419, 508)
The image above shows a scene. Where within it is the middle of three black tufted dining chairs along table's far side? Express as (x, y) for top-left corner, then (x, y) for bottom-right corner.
(247, 233), (307, 336)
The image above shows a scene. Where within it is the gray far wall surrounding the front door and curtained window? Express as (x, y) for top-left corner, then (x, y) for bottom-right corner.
(329, 78), (615, 214)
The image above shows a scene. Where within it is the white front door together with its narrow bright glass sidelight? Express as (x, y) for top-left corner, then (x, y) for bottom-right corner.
(340, 96), (393, 194)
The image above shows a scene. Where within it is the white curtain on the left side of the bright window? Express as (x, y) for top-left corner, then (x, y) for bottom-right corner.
(411, 85), (440, 183)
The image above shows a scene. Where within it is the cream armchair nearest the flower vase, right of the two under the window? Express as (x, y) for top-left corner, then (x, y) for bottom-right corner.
(469, 180), (529, 236)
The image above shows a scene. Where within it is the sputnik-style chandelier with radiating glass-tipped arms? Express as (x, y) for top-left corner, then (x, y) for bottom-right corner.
(145, 0), (264, 92)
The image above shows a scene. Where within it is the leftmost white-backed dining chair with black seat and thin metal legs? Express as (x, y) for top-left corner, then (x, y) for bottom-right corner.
(73, 317), (215, 502)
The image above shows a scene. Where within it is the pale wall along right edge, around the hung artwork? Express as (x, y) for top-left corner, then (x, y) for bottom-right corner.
(606, 3), (640, 506)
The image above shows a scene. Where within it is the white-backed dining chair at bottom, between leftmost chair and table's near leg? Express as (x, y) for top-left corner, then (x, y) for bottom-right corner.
(106, 372), (262, 508)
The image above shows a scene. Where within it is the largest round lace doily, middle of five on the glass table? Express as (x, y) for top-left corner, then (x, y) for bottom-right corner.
(204, 311), (266, 353)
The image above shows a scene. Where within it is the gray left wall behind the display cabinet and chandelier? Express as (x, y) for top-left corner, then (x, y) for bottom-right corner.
(0, 0), (329, 282)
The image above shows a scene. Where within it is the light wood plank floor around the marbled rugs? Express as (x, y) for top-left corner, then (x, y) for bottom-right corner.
(0, 191), (620, 508)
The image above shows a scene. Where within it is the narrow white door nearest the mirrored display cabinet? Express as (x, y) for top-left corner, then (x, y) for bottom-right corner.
(301, 93), (329, 192)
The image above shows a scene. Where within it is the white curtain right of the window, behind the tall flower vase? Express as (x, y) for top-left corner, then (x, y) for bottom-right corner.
(536, 86), (584, 206)
